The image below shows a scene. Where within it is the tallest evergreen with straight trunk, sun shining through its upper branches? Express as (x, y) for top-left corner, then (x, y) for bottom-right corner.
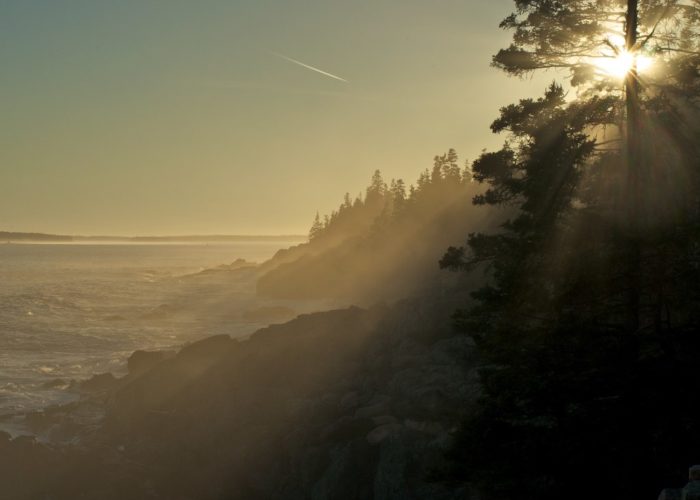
(484, 0), (700, 333)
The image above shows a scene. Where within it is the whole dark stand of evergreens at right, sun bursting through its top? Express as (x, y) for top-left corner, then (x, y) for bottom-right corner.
(441, 0), (700, 499)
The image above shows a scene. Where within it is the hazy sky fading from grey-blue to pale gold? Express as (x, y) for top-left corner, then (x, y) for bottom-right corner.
(0, 0), (553, 235)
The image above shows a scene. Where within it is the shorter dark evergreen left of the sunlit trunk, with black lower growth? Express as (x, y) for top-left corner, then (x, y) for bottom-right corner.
(442, 86), (700, 499)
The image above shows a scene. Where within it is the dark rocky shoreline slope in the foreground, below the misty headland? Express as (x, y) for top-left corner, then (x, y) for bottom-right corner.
(0, 301), (479, 500)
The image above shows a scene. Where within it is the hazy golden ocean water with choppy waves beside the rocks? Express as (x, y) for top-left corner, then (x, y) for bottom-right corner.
(0, 241), (294, 417)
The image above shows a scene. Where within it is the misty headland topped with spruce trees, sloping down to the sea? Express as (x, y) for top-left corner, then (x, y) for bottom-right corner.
(258, 149), (486, 304)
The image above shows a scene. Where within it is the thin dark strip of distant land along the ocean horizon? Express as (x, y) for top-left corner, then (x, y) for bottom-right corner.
(0, 231), (307, 243)
